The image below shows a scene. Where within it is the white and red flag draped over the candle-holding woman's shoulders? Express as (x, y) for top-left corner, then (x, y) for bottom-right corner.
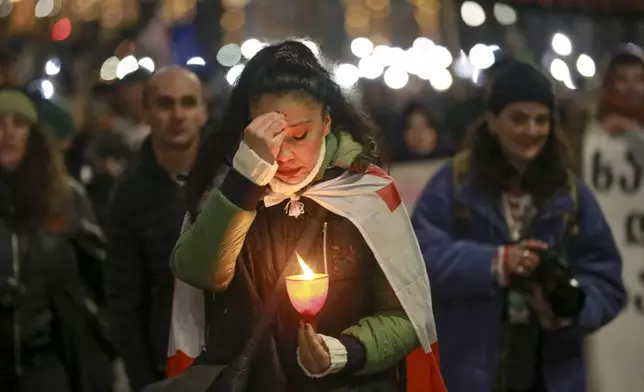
(167, 165), (446, 392)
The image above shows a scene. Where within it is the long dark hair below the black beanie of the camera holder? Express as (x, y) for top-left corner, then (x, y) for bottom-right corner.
(469, 113), (570, 205)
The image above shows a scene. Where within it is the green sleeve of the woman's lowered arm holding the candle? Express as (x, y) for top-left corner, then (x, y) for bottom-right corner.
(343, 268), (420, 374)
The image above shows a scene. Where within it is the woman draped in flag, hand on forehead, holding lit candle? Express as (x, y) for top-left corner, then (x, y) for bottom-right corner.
(171, 41), (444, 392)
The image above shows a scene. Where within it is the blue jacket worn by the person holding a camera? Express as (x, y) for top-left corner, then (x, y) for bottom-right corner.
(412, 163), (626, 392)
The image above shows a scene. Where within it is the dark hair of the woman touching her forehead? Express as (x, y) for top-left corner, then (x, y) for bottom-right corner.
(186, 41), (378, 214)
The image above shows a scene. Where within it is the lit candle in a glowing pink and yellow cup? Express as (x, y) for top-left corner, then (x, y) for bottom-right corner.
(286, 255), (329, 328)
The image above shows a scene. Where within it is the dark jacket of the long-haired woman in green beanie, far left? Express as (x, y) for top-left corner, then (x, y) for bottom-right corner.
(0, 180), (113, 391)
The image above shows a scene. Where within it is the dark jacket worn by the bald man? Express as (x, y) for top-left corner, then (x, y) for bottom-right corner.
(105, 139), (184, 391)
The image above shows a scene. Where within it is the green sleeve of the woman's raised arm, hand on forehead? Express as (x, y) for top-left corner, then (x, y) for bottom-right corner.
(170, 189), (255, 291)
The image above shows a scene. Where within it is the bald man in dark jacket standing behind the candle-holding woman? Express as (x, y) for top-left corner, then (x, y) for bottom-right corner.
(105, 67), (206, 391)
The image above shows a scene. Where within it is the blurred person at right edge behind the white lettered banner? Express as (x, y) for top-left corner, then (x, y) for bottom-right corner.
(589, 44), (644, 168)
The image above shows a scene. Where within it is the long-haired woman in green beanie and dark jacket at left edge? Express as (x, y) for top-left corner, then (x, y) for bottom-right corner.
(0, 87), (114, 392)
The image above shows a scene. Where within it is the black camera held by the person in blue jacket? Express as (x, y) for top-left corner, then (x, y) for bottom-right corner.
(516, 249), (586, 318)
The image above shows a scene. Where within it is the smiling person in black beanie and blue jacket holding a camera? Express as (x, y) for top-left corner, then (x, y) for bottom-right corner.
(412, 63), (626, 392)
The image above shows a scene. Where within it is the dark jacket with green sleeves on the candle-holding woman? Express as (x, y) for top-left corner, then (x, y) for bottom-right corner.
(171, 134), (419, 392)
